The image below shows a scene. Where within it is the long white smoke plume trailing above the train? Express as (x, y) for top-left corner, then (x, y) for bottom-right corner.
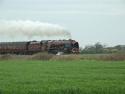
(0, 21), (71, 38)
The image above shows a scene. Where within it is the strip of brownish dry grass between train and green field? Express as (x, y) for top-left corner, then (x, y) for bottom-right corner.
(0, 53), (125, 61)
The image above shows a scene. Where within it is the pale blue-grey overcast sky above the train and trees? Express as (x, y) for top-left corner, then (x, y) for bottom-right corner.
(0, 0), (125, 47)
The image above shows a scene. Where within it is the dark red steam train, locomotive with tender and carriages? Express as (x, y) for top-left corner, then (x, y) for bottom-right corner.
(0, 39), (79, 54)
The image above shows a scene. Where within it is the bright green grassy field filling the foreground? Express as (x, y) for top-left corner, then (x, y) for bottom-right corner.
(0, 60), (125, 94)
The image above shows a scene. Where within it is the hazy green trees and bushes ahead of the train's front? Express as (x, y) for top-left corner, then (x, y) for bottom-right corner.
(80, 42), (125, 54)
